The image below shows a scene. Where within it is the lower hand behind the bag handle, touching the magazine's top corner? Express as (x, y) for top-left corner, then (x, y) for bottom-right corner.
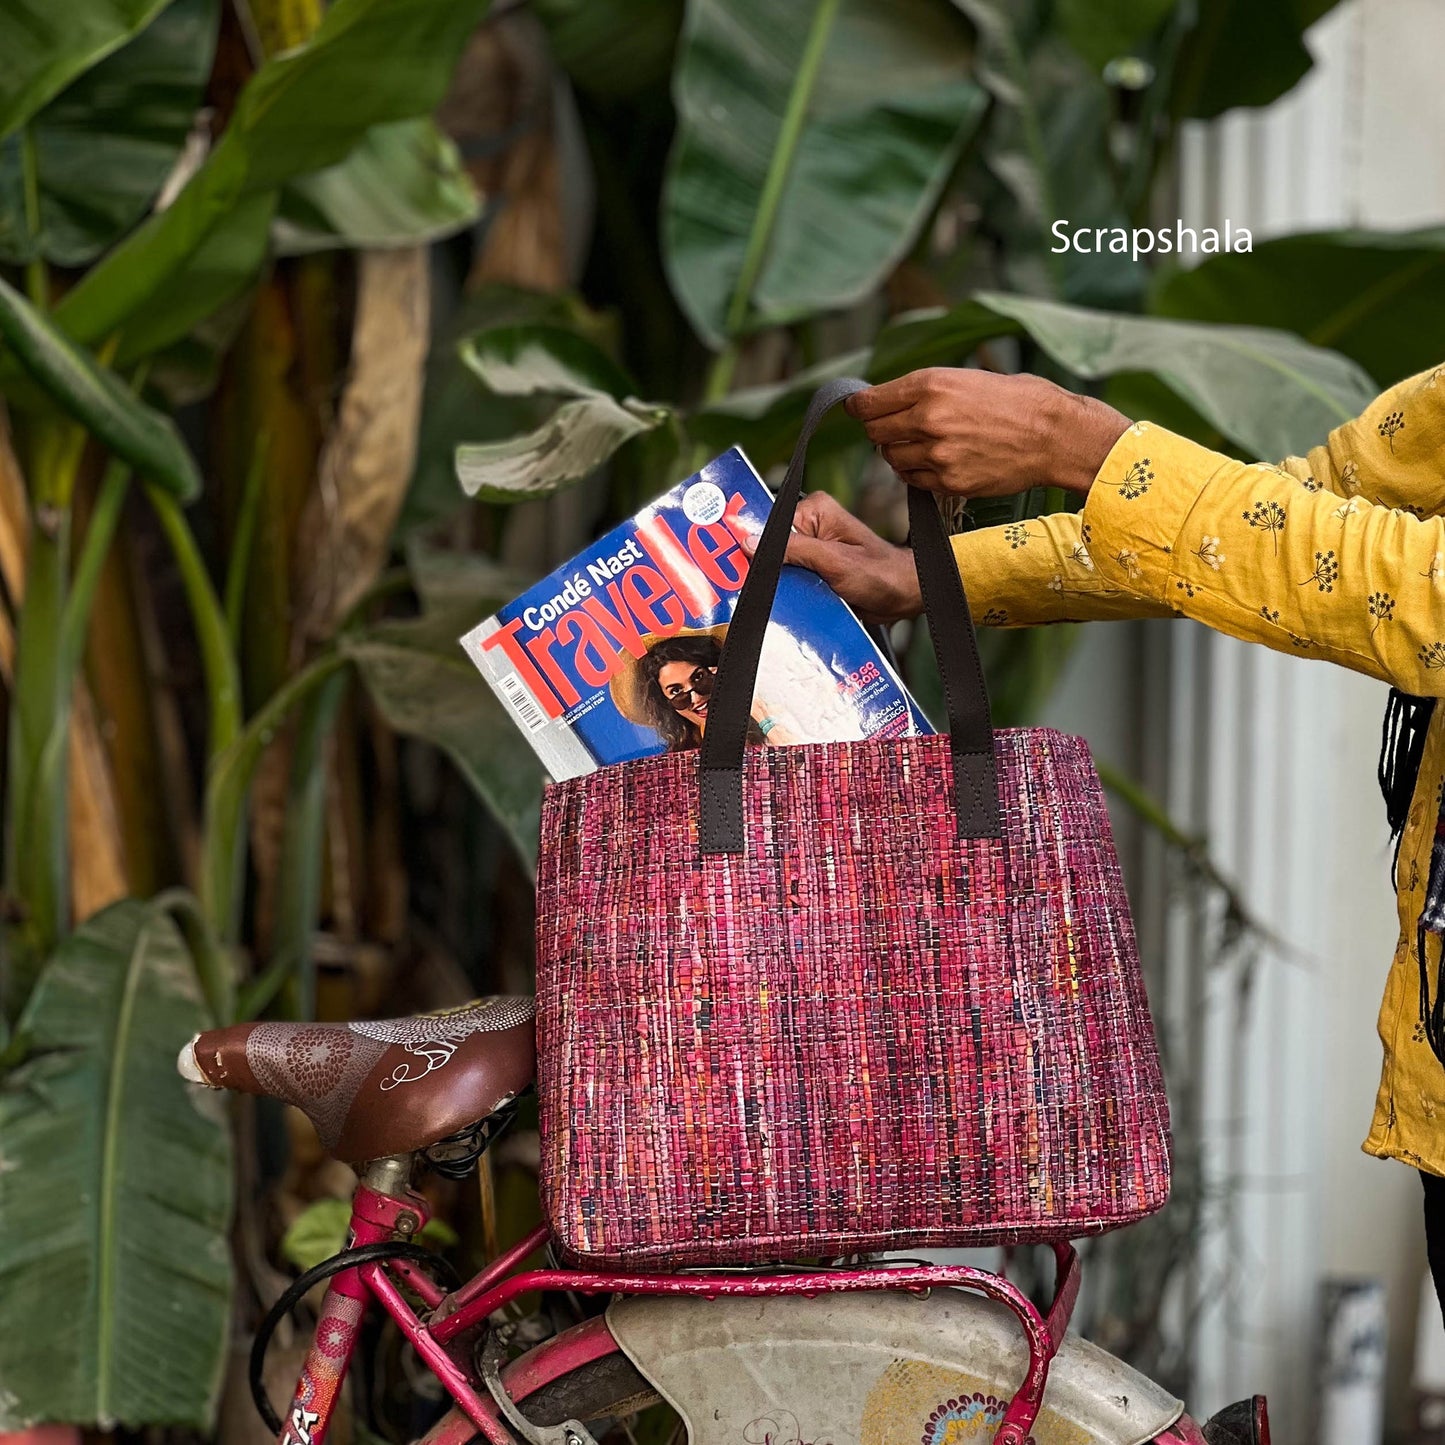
(751, 491), (923, 623)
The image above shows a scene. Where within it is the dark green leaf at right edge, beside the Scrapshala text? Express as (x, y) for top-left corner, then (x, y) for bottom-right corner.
(1150, 227), (1445, 384)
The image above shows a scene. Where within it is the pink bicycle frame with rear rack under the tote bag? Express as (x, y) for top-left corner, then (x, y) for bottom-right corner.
(279, 1159), (1204, 1445)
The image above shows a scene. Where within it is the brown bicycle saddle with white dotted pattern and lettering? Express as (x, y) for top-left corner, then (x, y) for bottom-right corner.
(176, 997), (536, 1163)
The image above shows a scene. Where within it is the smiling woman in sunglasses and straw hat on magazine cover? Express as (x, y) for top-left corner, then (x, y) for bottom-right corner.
(611, 623), (798, 753)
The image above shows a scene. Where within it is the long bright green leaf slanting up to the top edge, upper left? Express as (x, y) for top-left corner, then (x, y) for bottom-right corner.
(55, 0), (487, 355)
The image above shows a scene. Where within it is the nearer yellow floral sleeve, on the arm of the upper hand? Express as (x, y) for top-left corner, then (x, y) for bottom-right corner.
(1082, 368), (1445, 696)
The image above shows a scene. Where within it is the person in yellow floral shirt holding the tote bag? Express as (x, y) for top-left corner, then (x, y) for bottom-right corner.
(788, 366), (1445, 1323)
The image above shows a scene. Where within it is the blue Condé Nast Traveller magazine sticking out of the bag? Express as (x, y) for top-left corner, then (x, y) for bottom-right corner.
(462, 448), (933, 779)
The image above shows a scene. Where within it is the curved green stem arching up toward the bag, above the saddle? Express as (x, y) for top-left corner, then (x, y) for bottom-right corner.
(201, 652), (350, 942)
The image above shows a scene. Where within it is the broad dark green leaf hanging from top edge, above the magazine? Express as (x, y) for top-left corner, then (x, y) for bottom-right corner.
(662, 0), (984, 344)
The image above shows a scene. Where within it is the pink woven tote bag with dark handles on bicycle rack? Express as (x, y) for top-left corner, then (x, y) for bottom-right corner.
(536, 380), (1169, 1269)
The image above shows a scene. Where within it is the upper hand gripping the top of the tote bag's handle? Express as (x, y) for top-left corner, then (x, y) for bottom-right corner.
(845, 367), (1129, 497)
